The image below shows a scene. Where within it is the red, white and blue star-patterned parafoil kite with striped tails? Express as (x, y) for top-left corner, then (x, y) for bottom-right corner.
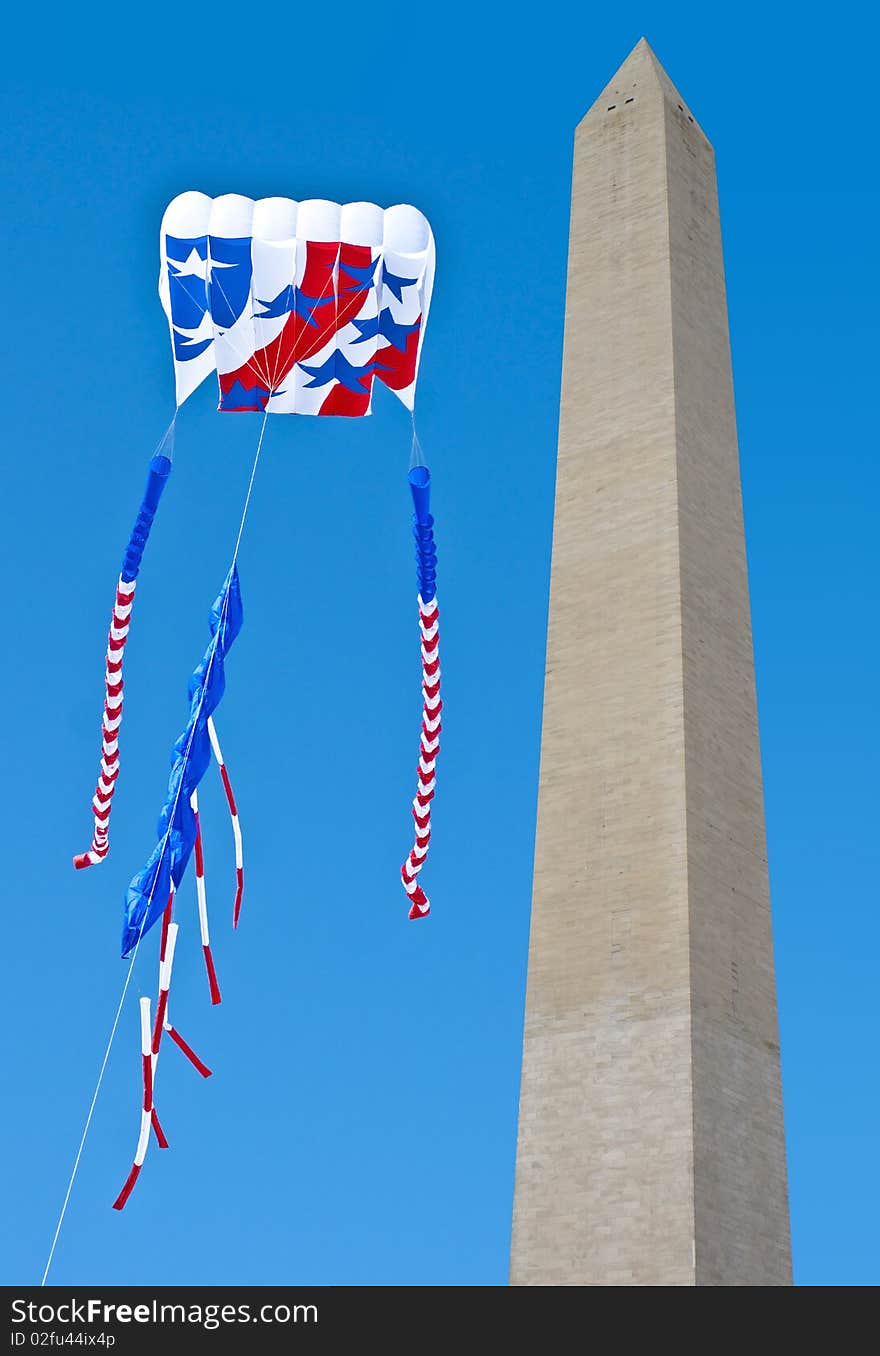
(73, 193), (442, 1210)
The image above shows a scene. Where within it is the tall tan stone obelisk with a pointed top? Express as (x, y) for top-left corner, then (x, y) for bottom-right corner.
(510, 39), (791, 1285)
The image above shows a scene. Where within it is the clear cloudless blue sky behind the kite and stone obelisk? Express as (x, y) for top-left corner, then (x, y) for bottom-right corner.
(0, 0), (880, 1285)
